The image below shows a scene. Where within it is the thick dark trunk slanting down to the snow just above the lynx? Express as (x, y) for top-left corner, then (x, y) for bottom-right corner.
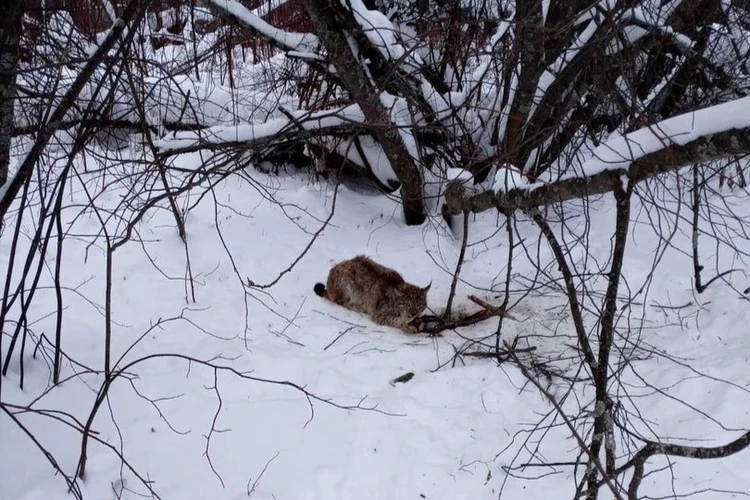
(304, 0), (425, 226)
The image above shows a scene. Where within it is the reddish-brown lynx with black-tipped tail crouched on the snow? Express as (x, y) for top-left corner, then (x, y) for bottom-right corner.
(314, 255), (432, 333)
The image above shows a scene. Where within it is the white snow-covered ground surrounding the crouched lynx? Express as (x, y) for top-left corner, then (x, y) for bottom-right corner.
(0, 161), (750, 500)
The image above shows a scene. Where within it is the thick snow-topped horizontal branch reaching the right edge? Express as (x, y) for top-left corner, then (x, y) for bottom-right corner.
(444, 97), (750, 215)
